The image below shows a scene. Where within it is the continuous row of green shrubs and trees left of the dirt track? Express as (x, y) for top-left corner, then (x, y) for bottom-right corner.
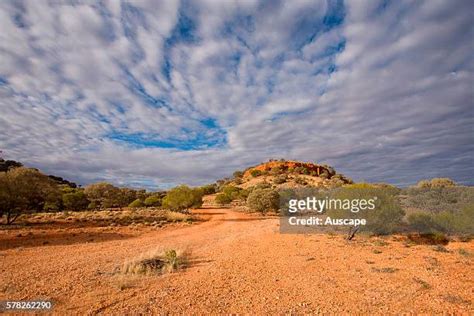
(0, 159), (202, 224)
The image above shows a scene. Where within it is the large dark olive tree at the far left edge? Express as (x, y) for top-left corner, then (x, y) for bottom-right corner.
(0, 167), (59, 224)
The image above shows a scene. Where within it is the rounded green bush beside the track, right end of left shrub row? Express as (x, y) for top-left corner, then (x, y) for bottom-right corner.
(163, 185), (203, 211)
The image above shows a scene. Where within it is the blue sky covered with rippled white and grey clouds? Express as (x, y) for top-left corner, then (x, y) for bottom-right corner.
(0, 0), (474, 189)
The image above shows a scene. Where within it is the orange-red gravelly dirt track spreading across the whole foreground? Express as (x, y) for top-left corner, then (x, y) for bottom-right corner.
(0, 208), (474, 314)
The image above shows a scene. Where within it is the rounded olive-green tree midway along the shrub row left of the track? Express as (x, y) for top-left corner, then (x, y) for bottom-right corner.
(84, 182), (123, 209)
